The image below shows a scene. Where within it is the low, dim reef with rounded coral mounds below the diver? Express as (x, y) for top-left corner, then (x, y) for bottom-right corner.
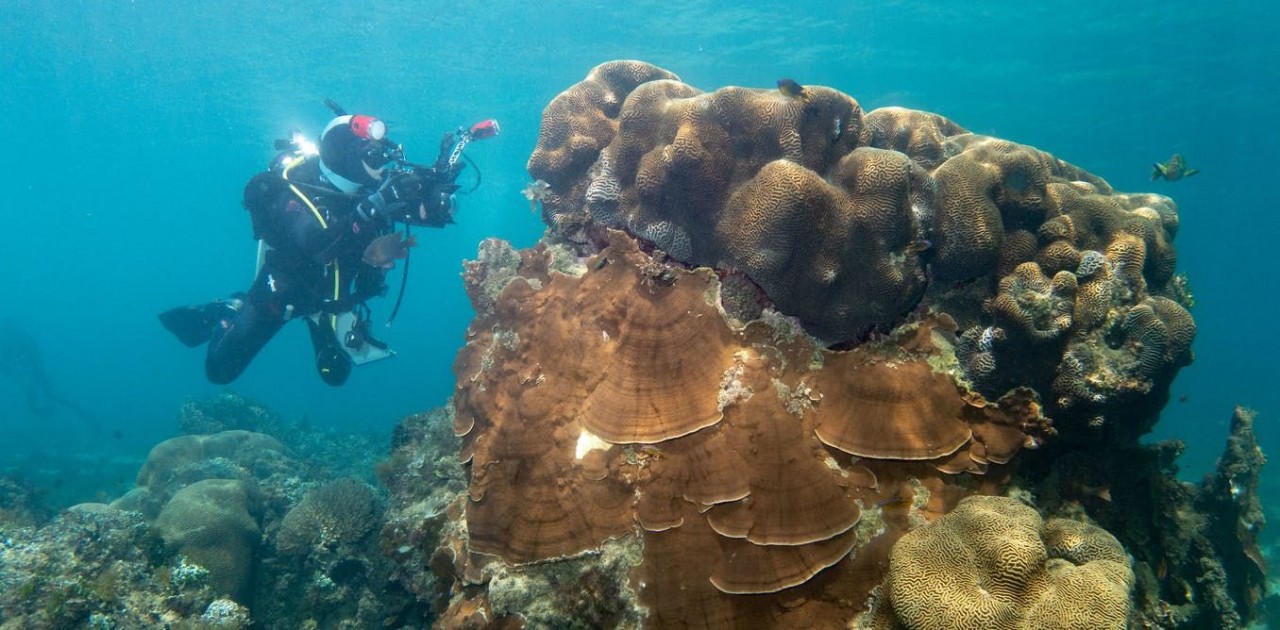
(0, 394), (409, 629)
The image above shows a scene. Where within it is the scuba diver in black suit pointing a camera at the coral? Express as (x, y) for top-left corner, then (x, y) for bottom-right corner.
(160, 100), (498, 385)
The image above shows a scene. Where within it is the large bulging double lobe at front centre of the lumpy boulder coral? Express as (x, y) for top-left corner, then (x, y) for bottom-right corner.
(716, 147), (925, 341)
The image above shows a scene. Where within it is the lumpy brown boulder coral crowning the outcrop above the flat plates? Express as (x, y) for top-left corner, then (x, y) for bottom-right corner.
(529, 61), (1194, 439)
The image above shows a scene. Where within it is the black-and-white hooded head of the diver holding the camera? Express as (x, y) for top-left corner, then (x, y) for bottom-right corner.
(320, 114), (390, 193)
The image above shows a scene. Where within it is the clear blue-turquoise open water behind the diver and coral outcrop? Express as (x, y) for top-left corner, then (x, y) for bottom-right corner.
(0, 0), (1280, 484)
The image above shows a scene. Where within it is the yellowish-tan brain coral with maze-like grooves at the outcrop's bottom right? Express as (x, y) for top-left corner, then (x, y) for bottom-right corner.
(873, 497), (1134, 630)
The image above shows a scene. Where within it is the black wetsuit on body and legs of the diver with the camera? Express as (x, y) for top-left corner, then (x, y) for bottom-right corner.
(205, 159), (392, 385)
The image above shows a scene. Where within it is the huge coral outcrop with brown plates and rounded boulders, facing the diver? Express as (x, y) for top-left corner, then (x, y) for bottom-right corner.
(383, 61), (1263, 629)
